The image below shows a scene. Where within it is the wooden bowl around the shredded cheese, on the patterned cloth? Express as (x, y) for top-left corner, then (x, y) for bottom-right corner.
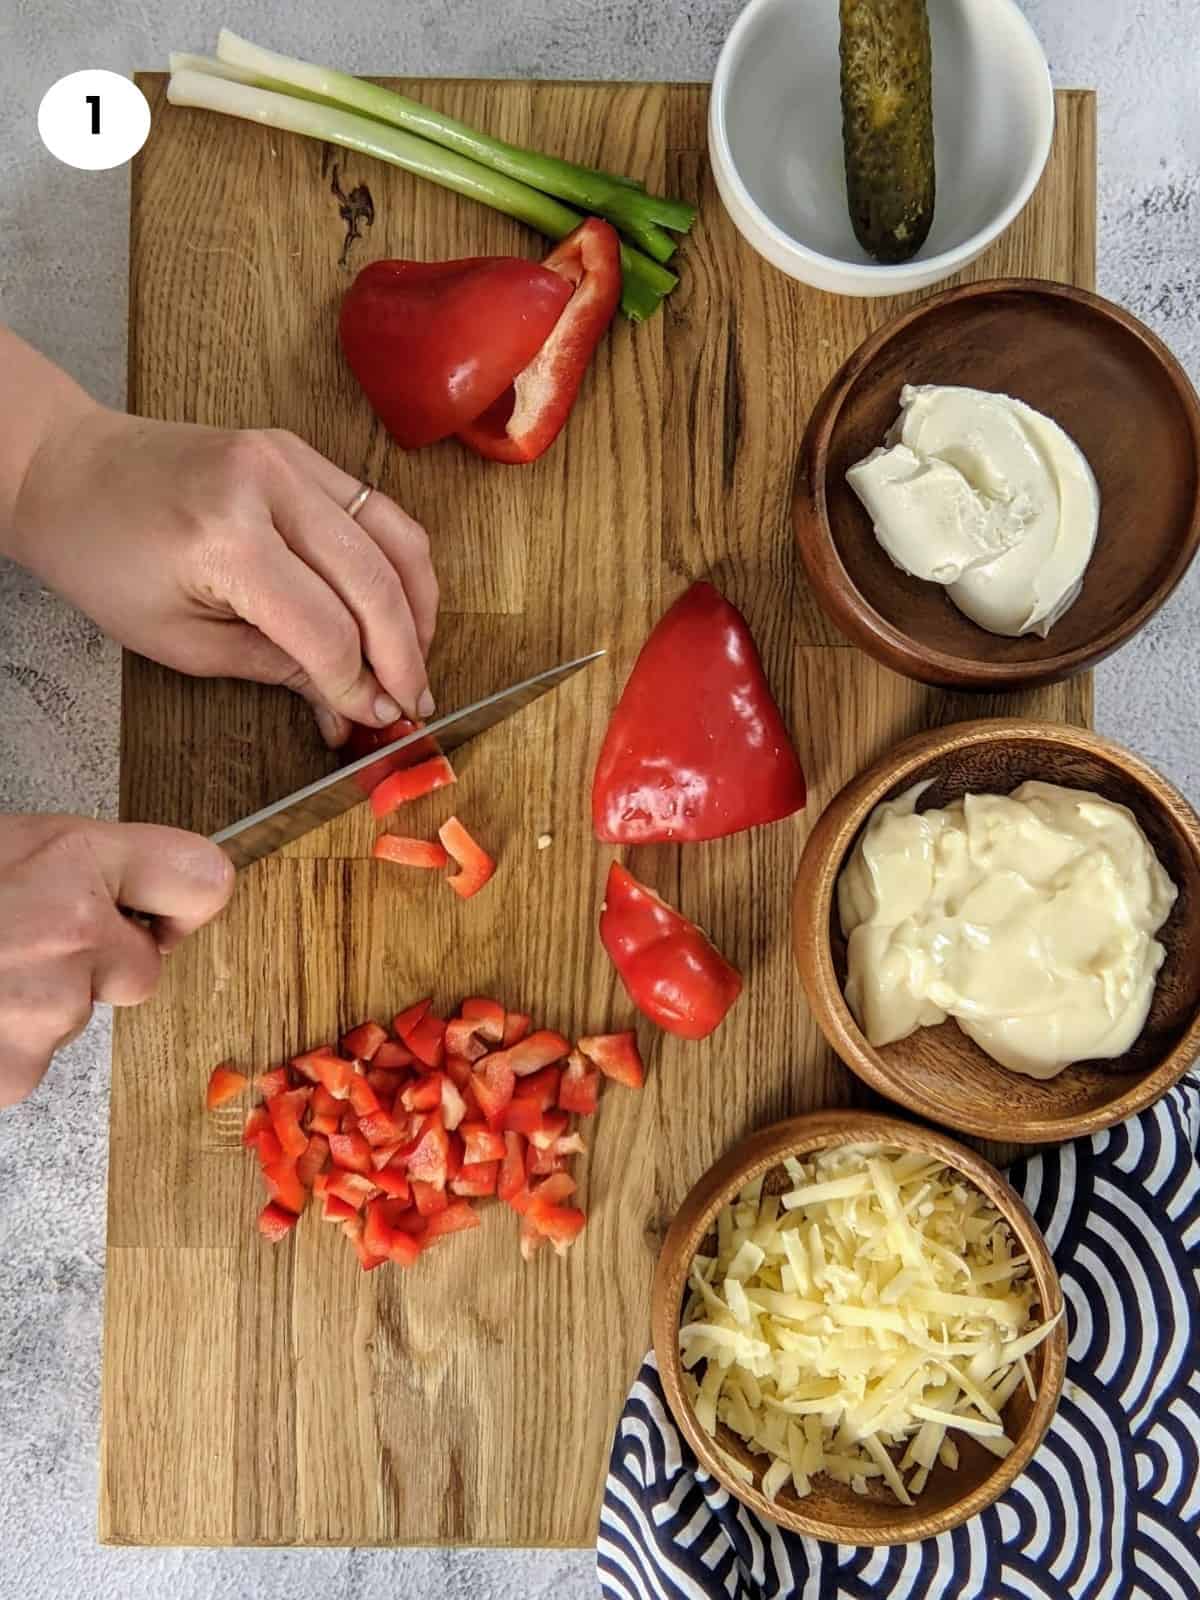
(653, 1110), (1067, 1544)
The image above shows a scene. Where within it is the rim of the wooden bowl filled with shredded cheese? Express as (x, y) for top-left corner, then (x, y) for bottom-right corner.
(653, 1110), (1067, 1546)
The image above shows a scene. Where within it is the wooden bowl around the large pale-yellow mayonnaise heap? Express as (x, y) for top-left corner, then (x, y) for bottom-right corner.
(792, 718), (1200, 1141)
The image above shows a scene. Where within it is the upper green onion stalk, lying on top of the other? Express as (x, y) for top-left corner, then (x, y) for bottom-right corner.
(216, 27), (696, 261)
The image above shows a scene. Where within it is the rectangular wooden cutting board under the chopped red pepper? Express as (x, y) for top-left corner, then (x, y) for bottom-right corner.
(101, 75), (1094, 1546)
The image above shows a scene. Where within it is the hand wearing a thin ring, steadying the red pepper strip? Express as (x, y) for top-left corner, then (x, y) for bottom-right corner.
(10, 400), (437, 746)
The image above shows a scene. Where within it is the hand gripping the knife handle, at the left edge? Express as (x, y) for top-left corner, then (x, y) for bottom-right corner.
(0, 816), (234, 1106)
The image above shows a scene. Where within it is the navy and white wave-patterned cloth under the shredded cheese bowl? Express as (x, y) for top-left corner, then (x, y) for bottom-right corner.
(597, 1077), (1200, 1600)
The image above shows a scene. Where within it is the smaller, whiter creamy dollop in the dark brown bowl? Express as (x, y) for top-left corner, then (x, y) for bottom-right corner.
(846, 384), (1099, 638)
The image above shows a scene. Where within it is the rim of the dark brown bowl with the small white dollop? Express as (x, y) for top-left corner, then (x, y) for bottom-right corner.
(792, 277), (1200, 690)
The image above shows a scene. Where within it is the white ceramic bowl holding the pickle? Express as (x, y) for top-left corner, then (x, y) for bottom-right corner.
(709, 0), (1054, 294)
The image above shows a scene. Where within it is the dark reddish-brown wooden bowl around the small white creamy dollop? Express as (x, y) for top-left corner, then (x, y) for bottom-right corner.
(792, 278), (1200, 690)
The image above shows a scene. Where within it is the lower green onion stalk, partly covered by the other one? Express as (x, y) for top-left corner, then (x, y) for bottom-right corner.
(166, 68), (678, 322)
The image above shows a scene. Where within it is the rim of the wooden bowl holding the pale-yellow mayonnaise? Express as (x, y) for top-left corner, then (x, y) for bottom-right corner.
(792, 717), (1200, 1144)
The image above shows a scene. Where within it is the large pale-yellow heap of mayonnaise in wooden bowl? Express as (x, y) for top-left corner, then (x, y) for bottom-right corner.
(838, 782), (1178, 1078)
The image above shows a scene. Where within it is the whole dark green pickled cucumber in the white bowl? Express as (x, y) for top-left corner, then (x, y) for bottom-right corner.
(840, 0), (934, 262)
